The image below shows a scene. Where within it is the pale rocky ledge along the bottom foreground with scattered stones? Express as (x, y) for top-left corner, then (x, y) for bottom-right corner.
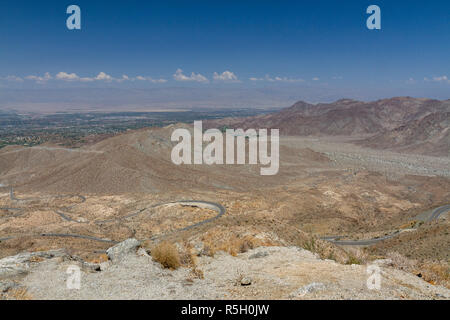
(0, 239), (450, 299)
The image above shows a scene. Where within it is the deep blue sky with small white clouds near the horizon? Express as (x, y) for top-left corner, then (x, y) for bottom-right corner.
(0, 0), (450, 98)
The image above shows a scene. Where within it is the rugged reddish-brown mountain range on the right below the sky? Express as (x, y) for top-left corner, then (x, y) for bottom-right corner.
(205, 97), (450, 156)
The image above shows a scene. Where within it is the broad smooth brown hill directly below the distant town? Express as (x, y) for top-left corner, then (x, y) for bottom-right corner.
(0, 125), (298, 194)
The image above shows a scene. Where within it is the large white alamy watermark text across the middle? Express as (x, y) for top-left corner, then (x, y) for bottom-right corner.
(171, 121), (280, 176)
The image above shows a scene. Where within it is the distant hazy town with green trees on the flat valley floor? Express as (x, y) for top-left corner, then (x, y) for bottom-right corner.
(0, 109), (270, 148)
